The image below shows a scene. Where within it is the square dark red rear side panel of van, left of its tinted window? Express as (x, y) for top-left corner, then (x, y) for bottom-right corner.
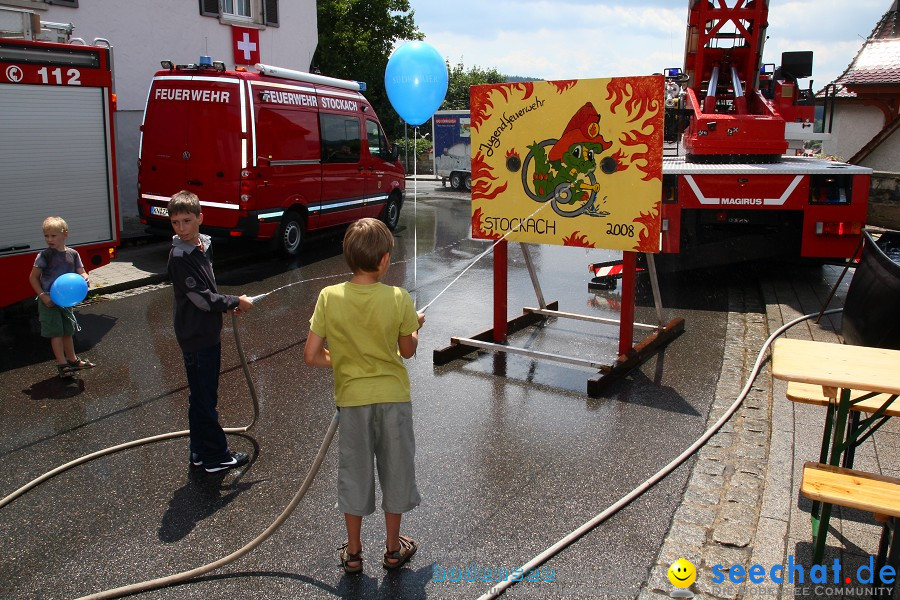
(256, 106), (319, 162)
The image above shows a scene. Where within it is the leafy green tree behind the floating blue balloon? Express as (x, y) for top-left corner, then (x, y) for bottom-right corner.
(311, 0), (424, 137)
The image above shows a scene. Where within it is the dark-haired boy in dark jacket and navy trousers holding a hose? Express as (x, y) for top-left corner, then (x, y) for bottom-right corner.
(168, 191), (253, 473)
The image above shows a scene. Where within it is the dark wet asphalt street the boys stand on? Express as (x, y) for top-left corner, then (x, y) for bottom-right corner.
(0, 197), (741, 599)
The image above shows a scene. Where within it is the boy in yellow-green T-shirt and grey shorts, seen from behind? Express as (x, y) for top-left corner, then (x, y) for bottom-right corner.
(303, 219), (425, 573)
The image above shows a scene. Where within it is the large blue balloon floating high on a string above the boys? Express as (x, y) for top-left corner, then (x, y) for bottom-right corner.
(384, 41), (449, 126)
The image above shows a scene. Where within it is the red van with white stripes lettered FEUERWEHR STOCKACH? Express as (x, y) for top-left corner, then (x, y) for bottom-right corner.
(138, 57), (405, 255)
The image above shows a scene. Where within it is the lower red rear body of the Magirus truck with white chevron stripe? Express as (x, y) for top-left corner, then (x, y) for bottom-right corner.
(662, 156), (872, 269)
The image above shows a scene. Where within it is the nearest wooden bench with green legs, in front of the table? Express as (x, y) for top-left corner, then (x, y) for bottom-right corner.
(800, 462), (900, 573)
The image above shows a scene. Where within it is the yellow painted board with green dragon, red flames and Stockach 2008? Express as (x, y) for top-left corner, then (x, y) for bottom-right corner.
(470, 75), (665, 252)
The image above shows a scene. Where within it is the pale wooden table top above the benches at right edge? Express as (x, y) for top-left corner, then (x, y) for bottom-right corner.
(772, 338), (900, 394)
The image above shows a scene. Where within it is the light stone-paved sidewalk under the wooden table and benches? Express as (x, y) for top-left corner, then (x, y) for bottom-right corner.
(639, 267), (900, 600)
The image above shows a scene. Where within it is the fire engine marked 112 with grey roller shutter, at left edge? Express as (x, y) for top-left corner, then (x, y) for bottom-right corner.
(0, 9), (119, 308)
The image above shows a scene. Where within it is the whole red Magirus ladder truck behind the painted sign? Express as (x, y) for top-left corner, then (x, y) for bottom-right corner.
(660, 0), (871, 268)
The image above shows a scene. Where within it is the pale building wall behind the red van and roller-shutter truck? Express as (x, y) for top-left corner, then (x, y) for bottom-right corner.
(0, 0), (318, 216)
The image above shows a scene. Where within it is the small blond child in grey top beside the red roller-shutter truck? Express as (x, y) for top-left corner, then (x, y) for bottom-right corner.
(28, 217), (94, 379)
